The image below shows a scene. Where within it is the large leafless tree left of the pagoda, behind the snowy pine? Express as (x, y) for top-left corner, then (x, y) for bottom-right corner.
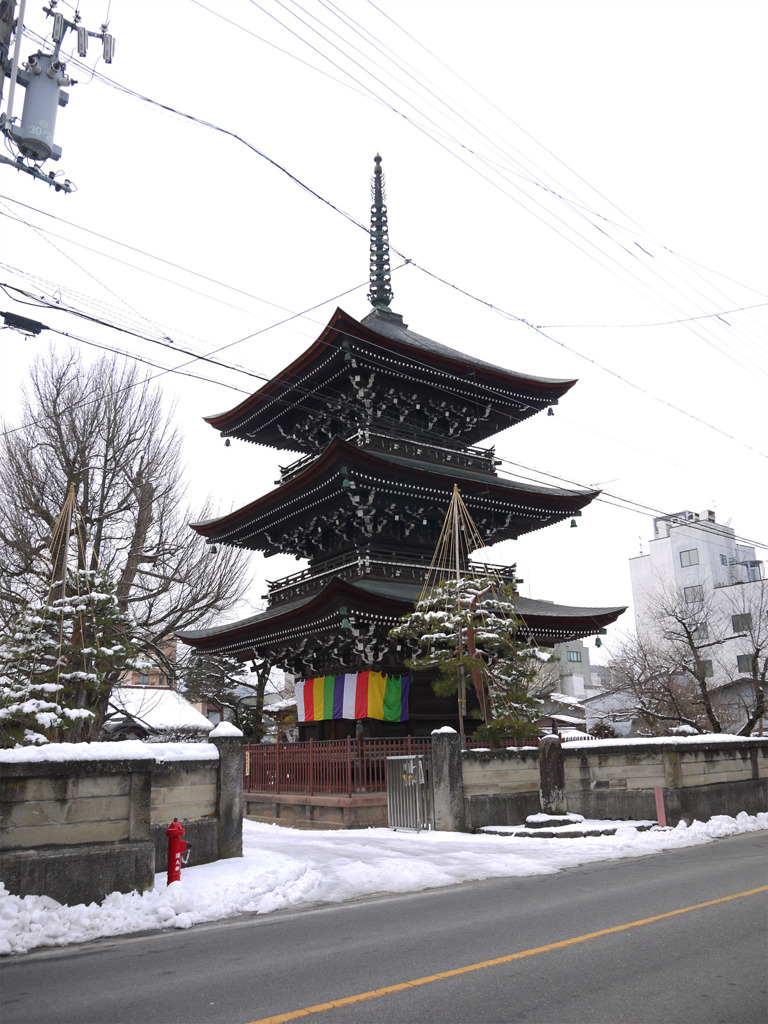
(0, 351), (248, 672)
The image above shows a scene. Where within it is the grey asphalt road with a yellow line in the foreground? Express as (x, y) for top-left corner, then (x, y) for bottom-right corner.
(0, 833), (768, 1024)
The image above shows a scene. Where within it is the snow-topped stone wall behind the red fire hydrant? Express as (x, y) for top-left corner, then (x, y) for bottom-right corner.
(0, 724), (243, 903)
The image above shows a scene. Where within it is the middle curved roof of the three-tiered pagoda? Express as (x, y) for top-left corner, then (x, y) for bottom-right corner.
(190, 438), (600, 541)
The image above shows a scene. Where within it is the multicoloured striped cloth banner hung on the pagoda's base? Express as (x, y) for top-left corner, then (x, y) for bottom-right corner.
(296, 672), (411, 722)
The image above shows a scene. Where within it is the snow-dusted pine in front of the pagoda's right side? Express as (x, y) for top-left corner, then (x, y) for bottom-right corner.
(390, 577), (541, 740)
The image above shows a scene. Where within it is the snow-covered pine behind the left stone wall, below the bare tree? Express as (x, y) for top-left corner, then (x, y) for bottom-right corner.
(0, 569), (136, 746)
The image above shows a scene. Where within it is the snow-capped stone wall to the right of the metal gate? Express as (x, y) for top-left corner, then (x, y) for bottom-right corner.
(432, 733), (768, 831)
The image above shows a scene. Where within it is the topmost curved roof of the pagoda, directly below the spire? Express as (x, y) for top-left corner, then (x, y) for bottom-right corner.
(204, 307), (577, 438)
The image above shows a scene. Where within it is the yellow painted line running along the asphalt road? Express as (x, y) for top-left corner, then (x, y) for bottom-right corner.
(251, 886), (768, 1024)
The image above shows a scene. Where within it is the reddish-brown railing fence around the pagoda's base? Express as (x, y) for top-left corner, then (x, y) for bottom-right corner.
(243, 736), (539, 797)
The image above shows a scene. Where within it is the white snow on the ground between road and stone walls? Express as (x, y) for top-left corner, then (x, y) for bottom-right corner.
(0, 812), (768, 954)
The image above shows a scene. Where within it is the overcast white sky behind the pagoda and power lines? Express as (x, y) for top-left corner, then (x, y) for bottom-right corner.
(0, 0), (768, 651)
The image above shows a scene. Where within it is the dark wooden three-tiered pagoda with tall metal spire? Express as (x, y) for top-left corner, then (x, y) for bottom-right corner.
(178, 157), (623, 738)
